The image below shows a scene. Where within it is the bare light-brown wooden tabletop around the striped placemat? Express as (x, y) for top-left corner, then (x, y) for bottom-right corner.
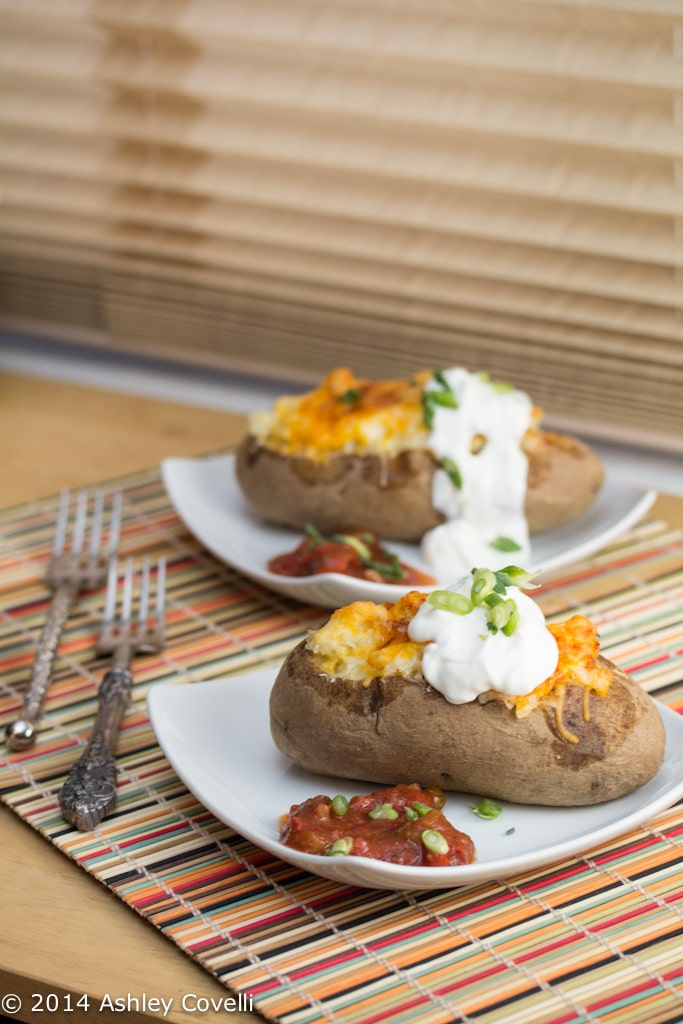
(0, 374), (683, 1024)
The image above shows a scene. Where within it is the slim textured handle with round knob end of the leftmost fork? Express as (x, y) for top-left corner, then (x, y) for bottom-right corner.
(7, 583), (78, 751)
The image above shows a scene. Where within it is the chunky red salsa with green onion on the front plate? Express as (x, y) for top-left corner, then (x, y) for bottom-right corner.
(280, 783), (474, 867)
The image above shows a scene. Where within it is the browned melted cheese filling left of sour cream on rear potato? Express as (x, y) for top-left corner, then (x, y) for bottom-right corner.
(249, 368), (430, 461)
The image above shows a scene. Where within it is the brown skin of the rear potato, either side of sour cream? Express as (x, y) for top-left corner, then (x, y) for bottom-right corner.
(236, 434), (604, 542)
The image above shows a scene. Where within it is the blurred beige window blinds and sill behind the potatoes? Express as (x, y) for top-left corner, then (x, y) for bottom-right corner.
(0, 0), (683, 490)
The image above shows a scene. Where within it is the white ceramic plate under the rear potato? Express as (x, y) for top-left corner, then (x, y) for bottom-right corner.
(162, 455), (656, 608)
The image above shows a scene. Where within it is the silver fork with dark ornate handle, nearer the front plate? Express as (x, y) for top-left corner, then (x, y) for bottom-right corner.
(59, 558), (166, 831)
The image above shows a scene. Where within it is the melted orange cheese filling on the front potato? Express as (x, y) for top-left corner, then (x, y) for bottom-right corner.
(306, 591), (612, 729)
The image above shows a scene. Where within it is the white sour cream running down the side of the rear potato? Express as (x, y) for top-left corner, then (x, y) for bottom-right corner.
(422, 367), (532, 577)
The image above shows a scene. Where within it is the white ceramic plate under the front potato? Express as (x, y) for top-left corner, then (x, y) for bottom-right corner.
(147, 669), (683, 890)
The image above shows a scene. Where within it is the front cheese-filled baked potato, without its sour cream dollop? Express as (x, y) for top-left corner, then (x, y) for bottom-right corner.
(270, 577), (665, 806)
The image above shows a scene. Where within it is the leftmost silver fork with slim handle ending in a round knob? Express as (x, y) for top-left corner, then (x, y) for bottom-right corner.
(6, 488), (121, 751)
